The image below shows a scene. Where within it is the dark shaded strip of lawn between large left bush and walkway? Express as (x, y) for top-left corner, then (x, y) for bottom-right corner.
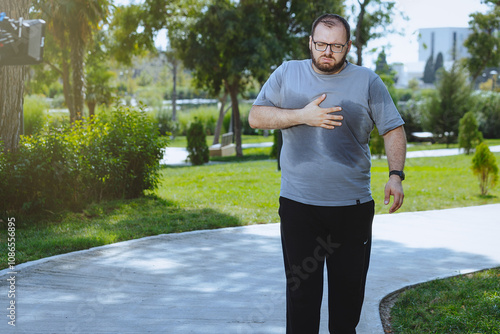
(0, 196), (244, 269)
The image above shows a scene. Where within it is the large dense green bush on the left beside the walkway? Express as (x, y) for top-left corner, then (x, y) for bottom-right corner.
(0, 106), (166, 212)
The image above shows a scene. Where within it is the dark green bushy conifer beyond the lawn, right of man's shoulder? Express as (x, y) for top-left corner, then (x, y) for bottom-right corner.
(424, 63), (471, 145)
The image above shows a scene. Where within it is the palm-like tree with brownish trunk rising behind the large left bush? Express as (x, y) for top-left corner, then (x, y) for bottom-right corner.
(36, 0), (111, 122)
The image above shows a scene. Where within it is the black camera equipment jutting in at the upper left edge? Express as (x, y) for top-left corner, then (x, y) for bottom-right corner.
(0, 13), (45, 66)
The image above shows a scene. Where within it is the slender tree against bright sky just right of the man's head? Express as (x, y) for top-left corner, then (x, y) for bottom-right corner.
(352, 0), (406, 66)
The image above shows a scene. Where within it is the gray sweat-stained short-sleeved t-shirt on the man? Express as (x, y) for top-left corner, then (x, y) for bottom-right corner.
(254, 59), (404, 206)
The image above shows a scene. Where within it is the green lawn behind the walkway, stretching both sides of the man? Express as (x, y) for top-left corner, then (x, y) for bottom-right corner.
(0, 148), (500, 269)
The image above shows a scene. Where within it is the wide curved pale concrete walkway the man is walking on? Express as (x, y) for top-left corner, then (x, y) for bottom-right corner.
(0, 204), (500, 334)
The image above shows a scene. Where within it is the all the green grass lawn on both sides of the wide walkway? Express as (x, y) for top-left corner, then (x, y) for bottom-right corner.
(0, 142), (500, 334)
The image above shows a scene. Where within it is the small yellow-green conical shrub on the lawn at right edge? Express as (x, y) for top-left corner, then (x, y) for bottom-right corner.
(472, 142), (498, 195)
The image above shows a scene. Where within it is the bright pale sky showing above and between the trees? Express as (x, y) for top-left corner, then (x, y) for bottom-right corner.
(115, 0), (488, 67)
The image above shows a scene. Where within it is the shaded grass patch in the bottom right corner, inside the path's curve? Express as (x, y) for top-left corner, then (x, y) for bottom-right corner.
(391, 268), (500, 334)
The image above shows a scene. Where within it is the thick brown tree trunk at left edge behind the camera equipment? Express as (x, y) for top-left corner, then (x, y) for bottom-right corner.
(0, 0), (31, 154)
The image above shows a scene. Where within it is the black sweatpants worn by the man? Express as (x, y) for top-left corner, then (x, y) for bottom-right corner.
(279, 197), (375, 334)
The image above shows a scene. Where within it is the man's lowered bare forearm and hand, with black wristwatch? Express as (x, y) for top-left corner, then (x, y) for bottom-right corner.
(383, 126), (406, 213)
